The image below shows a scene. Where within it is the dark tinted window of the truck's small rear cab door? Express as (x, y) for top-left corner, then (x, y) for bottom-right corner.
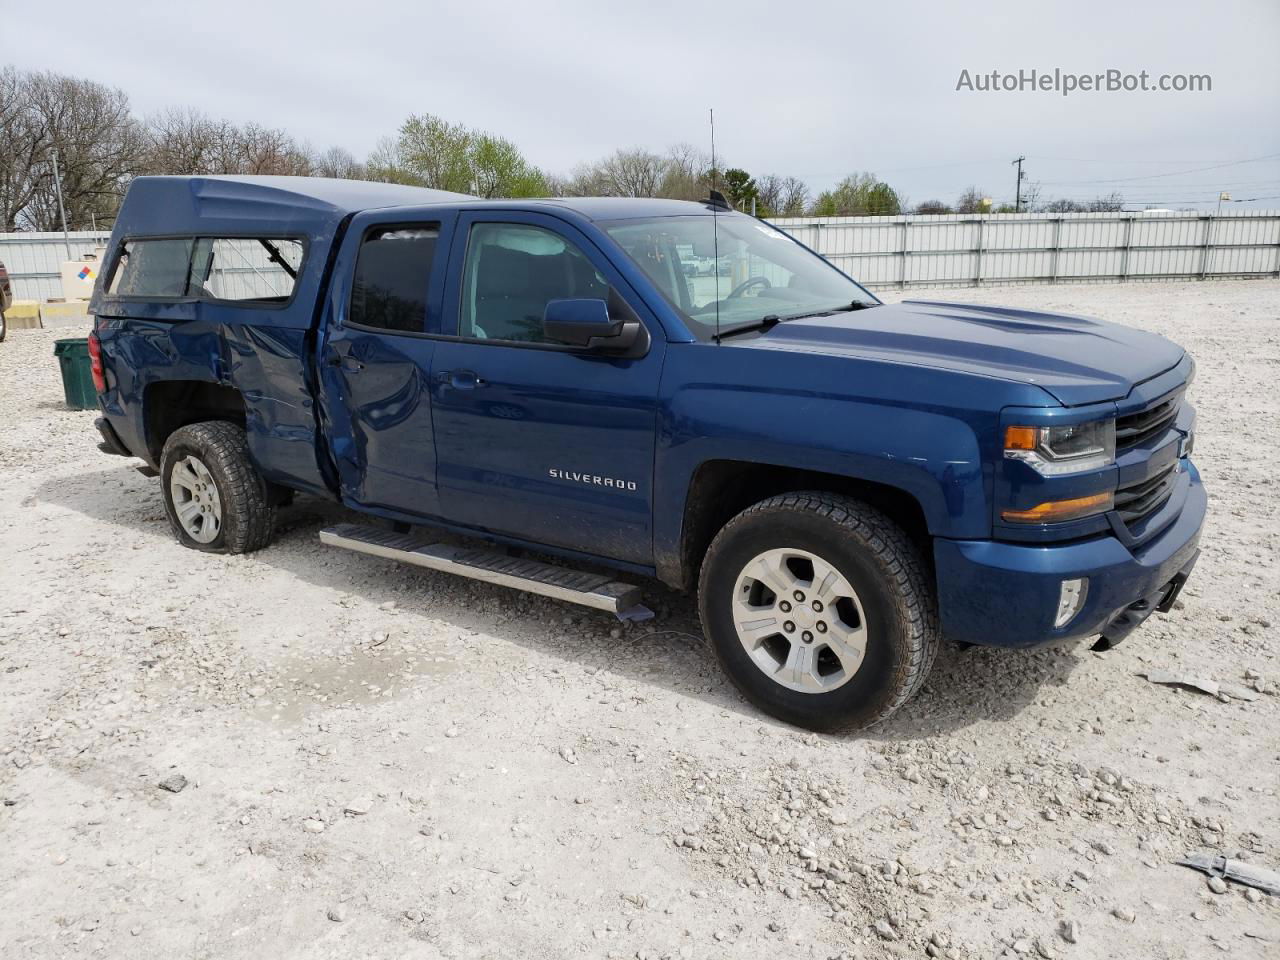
(349, 224), (440, 333)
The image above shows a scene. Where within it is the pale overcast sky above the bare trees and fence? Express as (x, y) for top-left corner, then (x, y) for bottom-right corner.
(0, 0), (1280, 207)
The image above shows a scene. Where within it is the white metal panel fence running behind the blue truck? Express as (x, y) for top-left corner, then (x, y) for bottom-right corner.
(0, 210), (1280, 300)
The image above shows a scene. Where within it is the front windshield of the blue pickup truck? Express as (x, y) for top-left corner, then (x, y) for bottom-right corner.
(602, 214), (879, 340)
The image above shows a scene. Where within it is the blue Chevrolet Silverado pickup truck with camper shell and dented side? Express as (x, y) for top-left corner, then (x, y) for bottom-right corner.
(90, 177), (1206, 730)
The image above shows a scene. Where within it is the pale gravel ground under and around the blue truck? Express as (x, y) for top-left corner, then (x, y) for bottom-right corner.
(0, 282), (1280, 960)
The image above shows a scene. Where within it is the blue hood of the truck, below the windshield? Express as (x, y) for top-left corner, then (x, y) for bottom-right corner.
(741, 300), (1183, 407)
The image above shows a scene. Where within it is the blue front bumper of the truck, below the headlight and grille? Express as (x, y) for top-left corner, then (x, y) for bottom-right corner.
(933, 461), (1208, 646)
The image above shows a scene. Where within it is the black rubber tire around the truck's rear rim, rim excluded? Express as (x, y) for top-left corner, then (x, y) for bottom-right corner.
(160, 420), (275, 553)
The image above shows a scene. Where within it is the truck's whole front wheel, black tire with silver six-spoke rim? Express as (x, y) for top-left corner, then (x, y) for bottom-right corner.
(699, 493), (940, 731)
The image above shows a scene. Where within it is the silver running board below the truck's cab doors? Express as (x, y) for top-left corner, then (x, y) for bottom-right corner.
(320, 524), (653, 621)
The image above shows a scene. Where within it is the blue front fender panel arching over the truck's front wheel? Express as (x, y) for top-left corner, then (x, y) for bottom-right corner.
(654, 344), (1002, 570)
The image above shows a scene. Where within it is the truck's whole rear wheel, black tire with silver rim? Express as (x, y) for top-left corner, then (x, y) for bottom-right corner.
(160, 421), (275, 553)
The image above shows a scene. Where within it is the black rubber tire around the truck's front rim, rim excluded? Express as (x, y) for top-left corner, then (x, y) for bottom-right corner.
(698, 492), (940, 731)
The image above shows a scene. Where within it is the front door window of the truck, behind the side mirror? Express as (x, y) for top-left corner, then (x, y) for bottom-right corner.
(458, 223), (609, 343)
